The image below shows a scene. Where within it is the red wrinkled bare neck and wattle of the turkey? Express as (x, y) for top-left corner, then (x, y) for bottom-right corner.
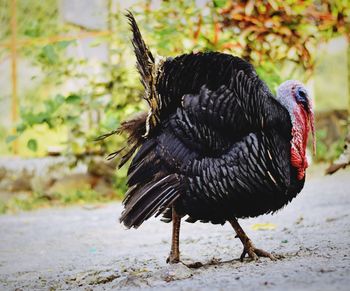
(291, 106), (309, 180)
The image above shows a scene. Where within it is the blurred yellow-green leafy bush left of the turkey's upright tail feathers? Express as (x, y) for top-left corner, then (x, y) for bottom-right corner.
(11, 10), (143, 155)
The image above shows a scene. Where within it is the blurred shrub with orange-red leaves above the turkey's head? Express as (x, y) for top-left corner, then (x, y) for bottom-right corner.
(214, 0), (350, 78)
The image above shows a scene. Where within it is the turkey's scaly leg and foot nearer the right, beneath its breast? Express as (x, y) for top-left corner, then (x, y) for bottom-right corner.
(229, 218), (276, 262)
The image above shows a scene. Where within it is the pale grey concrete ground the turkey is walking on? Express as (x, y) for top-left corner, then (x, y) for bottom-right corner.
(0, 170), (350, 290)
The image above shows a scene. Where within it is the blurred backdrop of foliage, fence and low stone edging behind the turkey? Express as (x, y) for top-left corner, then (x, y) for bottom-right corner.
(0, 0), (350, 213)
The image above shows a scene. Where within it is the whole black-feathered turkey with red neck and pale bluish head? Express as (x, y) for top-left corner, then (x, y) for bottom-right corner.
(102, 12), (315, 263)
